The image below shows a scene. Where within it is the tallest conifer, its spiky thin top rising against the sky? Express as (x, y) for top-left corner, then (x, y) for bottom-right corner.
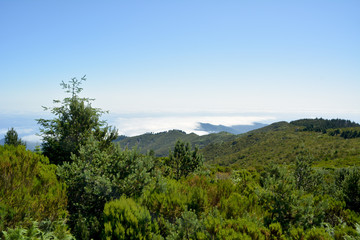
(37, 76), (117, 164)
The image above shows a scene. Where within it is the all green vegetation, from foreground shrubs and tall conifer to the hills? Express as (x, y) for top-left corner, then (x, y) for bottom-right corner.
(0, 78), (360, 240)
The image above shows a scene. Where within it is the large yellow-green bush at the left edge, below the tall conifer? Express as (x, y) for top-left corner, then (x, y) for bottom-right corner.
(0, 145), (67, 231)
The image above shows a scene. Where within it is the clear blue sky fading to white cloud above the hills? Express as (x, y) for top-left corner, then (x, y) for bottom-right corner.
(0, 0), (360, 138)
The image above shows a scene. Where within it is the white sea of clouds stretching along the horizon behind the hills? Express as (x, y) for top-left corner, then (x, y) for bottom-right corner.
(5, 113), (359, 143)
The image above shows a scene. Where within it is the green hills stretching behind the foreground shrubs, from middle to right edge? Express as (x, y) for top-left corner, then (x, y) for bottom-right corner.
(116, 118), (360, 163)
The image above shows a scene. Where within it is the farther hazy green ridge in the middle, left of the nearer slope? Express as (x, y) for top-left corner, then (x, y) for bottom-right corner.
(115, 130), (236, 157)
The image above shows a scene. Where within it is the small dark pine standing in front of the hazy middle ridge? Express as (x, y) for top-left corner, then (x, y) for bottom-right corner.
(165, 140), (203, 180)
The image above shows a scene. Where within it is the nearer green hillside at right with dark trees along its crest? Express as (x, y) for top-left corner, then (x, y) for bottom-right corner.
(201, 119), (360, 168)
